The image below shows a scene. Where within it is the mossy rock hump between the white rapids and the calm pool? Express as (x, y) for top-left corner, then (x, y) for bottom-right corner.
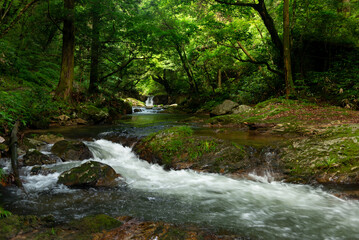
(134, 126), (261, 173)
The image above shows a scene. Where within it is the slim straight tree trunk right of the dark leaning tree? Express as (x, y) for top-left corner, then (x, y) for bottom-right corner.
(283, 0), (294, 99)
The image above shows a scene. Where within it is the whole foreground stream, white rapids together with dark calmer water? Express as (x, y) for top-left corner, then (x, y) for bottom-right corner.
(3, 113), (359, 239)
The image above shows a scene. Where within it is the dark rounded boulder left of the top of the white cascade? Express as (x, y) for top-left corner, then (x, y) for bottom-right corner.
(51, 140), (93, 161)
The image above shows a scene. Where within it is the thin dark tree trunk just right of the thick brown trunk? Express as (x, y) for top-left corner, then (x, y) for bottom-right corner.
(89, 0), (100, 93)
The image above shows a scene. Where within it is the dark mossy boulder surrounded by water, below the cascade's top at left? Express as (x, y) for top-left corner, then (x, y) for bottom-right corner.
(58, 161), (120, 188)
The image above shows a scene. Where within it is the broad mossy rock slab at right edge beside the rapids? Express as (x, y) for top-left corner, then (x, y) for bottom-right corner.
(283, 124), (359, 183)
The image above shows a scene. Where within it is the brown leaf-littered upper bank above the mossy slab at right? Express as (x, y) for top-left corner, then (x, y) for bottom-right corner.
(206, 98), (359, 133)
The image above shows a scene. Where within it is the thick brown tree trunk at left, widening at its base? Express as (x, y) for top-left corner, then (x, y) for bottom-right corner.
(55, 0), (75, 100)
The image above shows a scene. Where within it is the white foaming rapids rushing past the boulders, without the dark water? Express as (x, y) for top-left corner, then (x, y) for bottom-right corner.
(11, 140), (359, 239)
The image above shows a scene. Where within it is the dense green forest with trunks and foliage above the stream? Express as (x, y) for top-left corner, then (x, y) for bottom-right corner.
(0, 0), (359, 133)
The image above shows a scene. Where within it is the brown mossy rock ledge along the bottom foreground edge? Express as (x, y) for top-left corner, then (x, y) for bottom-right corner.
(0, 214), (243, 240)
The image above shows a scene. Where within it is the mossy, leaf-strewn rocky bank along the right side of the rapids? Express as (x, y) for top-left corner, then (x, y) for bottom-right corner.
(135, 99), (359, 188)
